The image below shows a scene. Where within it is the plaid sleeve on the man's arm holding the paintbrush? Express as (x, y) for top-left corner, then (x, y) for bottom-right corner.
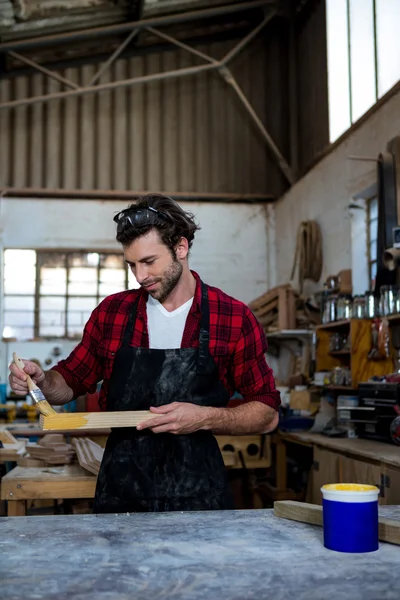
(52, 306), (103, 398)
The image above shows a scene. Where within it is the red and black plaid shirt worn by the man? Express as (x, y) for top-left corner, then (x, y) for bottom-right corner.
(53, 271), (280, 410)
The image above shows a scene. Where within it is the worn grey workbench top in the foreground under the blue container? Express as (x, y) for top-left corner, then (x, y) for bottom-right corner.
(0, 507), (400, 600)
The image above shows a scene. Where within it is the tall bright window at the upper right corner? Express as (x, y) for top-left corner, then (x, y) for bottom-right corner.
(326, 0), (400, 142)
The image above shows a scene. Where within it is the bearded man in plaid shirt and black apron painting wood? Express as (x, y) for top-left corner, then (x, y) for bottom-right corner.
(9, 194), (280, 513)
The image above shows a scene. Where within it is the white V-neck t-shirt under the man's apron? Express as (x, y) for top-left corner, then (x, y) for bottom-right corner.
(146, 295), (193, 350)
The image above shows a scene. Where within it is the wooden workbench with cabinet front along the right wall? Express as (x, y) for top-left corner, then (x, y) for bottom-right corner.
(271, 432), (400, 504)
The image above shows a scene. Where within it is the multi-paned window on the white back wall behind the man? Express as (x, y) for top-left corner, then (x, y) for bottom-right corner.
(3, 249), (138, 339)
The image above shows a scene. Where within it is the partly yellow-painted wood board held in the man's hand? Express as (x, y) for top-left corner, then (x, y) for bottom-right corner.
(39, 410), (157, 431)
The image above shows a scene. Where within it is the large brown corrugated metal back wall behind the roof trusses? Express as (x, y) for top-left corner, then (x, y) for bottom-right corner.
(0, 33), (288, 196)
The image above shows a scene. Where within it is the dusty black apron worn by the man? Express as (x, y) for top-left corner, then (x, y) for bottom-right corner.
(94, 282), (233, 513)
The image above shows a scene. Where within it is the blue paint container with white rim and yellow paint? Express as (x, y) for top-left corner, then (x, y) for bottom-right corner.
(321, 483), (379, 552)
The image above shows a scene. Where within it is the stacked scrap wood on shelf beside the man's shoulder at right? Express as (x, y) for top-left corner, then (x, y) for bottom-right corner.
(249, 283), (320, 333)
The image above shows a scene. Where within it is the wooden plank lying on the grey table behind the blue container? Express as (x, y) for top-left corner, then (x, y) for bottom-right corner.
(274, 500), (400, 546)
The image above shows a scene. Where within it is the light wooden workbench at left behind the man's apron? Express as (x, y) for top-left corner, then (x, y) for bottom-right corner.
(0, 465), (97, 516)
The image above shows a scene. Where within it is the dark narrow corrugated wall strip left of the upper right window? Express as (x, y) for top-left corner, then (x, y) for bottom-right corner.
(297, 0), (329, 173)
